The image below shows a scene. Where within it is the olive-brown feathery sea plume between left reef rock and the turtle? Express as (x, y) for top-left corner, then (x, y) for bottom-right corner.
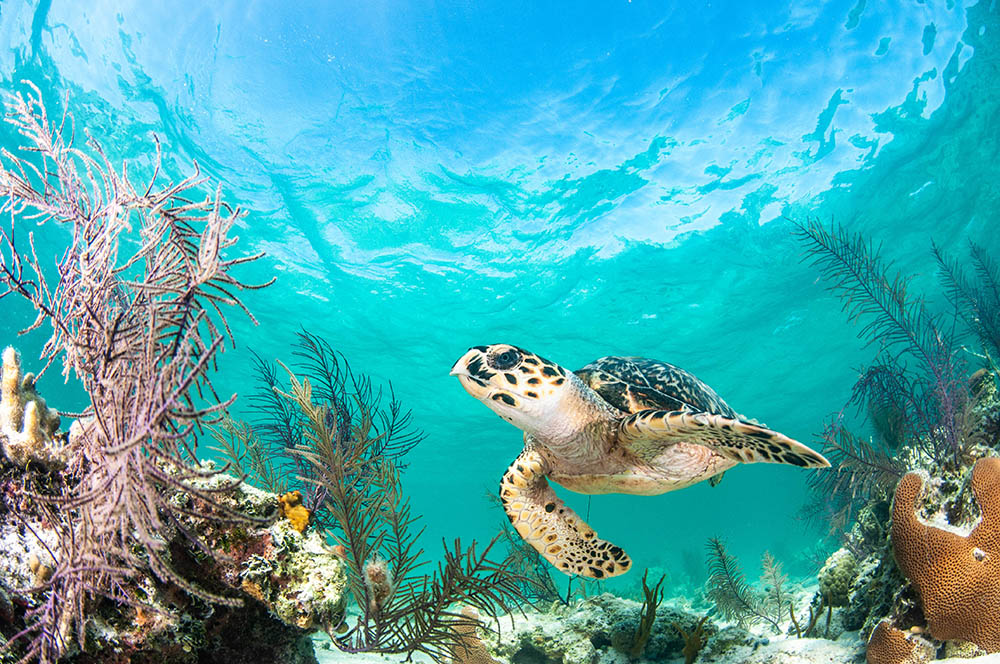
(232, 365), (528, 661)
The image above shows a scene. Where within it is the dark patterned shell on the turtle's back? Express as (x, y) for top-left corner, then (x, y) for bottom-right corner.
(574, 357), (739, 419)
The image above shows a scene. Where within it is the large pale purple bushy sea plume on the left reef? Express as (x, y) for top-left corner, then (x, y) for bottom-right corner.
(0, 84), (270, 662)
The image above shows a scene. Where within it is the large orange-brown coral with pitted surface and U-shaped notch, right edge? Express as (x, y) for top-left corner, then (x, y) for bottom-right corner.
(892, 458), (1000, 652)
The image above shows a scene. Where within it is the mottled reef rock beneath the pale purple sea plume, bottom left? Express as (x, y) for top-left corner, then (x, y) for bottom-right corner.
(0, 456), (347, 664)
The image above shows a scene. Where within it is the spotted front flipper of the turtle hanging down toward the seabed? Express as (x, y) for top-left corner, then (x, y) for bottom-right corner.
(500, 447), (632, 579)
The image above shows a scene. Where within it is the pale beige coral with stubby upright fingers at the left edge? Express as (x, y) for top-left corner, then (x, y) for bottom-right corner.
(0, 346), (66, 466)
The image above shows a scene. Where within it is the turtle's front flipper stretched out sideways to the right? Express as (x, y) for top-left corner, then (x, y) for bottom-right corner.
(618, 410), (830, 468)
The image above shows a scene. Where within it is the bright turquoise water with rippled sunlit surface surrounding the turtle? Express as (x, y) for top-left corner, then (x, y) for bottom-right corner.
(0, 0), (1000, 583)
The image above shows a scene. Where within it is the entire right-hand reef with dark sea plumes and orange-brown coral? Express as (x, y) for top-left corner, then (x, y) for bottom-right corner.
(794, 221), (1000, 664)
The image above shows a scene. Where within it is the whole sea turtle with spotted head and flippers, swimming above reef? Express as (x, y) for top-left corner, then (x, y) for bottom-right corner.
(451, 344), (830, 579)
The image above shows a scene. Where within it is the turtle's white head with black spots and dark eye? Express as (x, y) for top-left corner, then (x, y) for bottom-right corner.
(451, 344), (573, 434)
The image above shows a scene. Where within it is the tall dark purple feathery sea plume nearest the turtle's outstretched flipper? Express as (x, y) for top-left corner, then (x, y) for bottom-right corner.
(793, 221), (976, 532)
